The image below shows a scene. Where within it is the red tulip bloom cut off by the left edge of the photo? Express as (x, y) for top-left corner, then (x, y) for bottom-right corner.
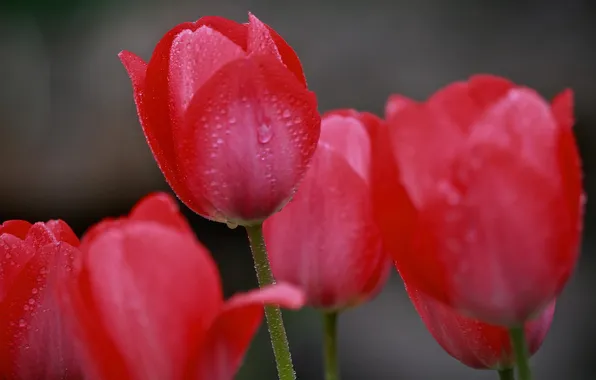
(0, 220), (81, 380)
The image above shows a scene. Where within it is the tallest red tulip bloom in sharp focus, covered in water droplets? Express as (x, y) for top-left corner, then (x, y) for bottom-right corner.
(120, 14), (320, 224)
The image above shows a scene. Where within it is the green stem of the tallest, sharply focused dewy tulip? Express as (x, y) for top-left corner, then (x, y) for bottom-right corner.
(246, 224), (296, 380)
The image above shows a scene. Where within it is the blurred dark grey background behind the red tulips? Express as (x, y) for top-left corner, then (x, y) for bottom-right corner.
(0, 0), (596, 380)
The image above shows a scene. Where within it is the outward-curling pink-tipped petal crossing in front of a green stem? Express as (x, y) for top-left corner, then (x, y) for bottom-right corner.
(188, 283), (304, 380)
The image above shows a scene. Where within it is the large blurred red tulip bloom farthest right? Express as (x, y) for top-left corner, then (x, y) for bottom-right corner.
(373, 76), (583, 325)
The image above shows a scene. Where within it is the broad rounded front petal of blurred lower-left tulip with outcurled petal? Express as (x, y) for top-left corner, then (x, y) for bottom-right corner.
(66, 221), (223, 379)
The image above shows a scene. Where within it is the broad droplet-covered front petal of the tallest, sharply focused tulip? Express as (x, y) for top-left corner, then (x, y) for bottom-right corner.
(176, 55), (320, 221)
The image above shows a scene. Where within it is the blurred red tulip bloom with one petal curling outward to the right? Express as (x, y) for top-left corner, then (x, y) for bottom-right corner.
(62, 194), (303, 380)
